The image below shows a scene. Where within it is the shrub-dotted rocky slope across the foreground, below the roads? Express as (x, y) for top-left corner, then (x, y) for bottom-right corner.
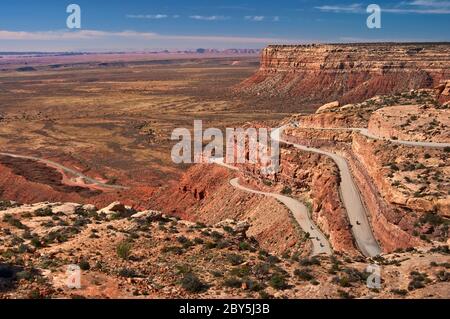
(0, 202), (450, 299)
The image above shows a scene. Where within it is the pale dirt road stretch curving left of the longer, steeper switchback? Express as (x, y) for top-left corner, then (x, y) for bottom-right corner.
(213, 158), (333, 256)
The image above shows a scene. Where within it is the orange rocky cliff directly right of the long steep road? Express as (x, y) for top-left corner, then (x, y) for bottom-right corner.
(348, 134), (449, 246)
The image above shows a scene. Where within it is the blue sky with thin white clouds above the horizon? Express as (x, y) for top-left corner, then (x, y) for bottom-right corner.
(0, 0), (450, 51)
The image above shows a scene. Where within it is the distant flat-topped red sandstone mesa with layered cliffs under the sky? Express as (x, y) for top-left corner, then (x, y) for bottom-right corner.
(239, 43), (450, 104)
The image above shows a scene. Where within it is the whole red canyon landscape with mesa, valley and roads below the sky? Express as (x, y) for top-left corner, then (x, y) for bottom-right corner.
(0, 47), (450, 298)
